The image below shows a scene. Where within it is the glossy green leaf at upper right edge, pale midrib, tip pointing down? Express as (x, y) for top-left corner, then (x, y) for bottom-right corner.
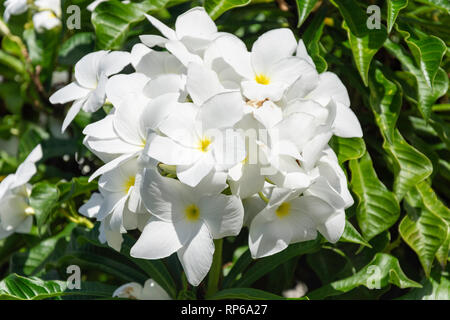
(385, 37), (448, 120)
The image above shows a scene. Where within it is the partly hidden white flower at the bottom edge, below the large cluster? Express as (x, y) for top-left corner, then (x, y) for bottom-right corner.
(113, 279), (172, 300)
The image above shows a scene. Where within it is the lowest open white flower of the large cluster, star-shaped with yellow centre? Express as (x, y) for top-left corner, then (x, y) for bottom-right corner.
(130, 169), (244, 286)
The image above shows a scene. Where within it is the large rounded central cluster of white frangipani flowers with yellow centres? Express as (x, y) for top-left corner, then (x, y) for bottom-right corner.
(51, 7), (362, 285)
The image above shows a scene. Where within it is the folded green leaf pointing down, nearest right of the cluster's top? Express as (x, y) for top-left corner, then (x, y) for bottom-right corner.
(342, 22), (387, 86)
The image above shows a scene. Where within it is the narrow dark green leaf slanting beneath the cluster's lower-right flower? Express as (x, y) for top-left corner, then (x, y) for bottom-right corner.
(233, 237), (321, 287)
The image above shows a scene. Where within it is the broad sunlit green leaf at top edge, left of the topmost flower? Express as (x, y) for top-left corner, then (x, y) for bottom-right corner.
(91, 0), (167, 50)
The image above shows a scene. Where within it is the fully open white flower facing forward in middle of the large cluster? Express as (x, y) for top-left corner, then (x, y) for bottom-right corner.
(147, 92), (245, 186)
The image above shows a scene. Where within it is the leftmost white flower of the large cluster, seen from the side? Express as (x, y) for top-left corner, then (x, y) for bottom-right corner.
(50, 50), (130, 131)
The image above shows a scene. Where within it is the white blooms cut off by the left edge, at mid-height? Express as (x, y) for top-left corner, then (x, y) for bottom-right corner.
(0, 145), (42, 239)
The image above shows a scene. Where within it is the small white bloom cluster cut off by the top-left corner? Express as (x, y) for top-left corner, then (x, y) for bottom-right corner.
(3, 0), (61, 32)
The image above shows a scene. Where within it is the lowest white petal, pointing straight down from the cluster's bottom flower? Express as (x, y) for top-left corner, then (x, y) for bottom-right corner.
(177, 225), (214, 286)
